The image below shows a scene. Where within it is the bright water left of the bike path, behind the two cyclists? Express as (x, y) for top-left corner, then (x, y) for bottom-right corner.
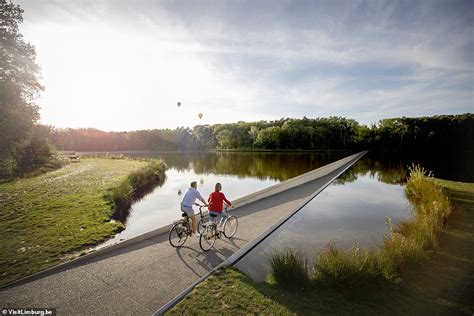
(94, 152), (348, 247)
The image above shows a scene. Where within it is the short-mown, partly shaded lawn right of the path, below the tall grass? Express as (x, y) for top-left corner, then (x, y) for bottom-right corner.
(168, 179), (474, 315)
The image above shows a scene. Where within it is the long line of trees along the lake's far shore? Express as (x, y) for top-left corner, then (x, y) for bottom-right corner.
(50, 113), (474, 152)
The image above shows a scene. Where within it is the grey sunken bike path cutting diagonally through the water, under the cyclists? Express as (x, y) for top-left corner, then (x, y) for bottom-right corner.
(0, 152), (357, 315)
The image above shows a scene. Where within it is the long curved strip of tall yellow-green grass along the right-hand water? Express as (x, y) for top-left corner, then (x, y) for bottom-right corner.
(313, 166), (452, 288)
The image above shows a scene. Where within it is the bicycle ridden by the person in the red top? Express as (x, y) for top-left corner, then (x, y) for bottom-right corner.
(199, 205), (239, 251)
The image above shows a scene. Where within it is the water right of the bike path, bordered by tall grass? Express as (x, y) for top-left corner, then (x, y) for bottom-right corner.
(236, 155), (412, 281)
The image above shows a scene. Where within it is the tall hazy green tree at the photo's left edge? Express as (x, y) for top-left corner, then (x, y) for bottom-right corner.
(0, 0), (51, 179)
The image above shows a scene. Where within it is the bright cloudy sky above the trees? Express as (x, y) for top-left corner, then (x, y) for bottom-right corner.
(14, 0), (474, 131)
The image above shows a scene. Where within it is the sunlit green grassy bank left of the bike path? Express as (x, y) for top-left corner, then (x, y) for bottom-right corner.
(0, 158), (164, 284)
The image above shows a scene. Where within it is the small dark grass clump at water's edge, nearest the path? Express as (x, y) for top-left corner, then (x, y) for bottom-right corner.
(271, 250), (310, 290)
